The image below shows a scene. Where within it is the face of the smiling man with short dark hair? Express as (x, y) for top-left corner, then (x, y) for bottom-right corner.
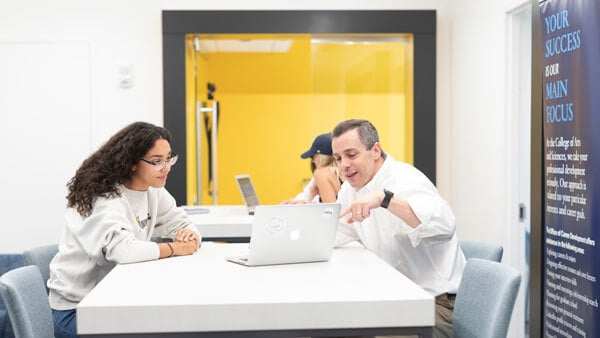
(331, 129), (381, 189)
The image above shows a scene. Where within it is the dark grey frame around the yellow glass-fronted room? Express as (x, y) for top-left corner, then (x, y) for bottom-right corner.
(162, 10), (436, 205)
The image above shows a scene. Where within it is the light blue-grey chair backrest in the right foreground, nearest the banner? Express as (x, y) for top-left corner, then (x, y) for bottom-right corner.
(452, 258), (521, 338)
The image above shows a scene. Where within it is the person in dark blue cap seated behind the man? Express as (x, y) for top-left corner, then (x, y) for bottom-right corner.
(283, 133), (343, 204)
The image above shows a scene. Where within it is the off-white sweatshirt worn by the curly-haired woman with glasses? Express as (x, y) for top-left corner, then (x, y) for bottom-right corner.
(48, 186), (198, 310)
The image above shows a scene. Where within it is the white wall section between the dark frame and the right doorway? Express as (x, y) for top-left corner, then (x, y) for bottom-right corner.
(438, 0), (524, 243)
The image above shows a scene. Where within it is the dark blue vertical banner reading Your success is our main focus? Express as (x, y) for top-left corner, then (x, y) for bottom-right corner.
(540, 0), (600, 337)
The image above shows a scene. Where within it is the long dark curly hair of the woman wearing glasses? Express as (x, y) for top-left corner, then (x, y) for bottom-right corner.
(67, 122), (171, 216)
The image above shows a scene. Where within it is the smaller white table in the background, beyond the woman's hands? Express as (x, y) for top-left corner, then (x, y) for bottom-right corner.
(184, 205), (253, 242)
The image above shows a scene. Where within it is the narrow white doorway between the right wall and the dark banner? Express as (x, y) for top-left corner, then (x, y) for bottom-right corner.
(505, 3), (532, 337)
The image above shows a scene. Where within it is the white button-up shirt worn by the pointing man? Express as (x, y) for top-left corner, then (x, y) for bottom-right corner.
(336, 154), (466, 296)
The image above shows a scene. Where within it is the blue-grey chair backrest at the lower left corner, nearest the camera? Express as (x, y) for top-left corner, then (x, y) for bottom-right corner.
(0, 265), (54, 338)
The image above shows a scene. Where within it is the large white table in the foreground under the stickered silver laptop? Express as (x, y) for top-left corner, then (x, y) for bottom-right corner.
(77, 242), (434, 337)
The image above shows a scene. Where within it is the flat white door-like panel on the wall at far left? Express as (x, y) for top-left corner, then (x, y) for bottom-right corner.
(0, 41), (91, 252)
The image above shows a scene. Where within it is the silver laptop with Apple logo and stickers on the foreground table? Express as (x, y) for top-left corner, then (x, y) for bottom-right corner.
(226, 203), (341, 266)
